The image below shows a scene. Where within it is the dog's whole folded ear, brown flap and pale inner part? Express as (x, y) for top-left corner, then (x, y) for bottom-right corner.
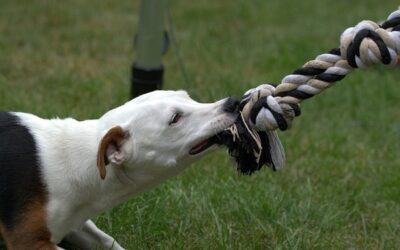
(97, 126), (129, 180)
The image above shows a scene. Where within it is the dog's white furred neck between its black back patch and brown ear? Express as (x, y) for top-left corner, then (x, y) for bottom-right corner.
(36, 117), (161, 241)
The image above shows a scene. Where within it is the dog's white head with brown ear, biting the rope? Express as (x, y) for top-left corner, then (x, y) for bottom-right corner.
(97, 91), (238, 179)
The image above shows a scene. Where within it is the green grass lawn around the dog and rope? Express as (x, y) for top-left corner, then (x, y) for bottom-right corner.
(0, 0), (400, 249)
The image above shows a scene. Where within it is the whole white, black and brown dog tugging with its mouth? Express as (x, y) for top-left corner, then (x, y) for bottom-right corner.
(0, 90), (238, 250)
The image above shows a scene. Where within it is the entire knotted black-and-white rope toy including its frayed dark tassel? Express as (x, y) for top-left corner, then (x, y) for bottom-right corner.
(219, 10), (400, 174)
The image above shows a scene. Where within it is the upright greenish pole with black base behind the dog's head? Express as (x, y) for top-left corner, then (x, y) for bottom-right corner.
(131, 0), (168, 98)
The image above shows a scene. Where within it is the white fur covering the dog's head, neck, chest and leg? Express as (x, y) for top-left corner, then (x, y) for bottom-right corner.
(15, 91), (236, 249)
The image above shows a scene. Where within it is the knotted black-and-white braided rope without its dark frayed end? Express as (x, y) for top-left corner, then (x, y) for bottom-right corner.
(242, 10), (400, 131)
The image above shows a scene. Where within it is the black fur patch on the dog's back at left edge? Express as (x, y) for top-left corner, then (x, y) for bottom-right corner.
(0, 112), (45, 230)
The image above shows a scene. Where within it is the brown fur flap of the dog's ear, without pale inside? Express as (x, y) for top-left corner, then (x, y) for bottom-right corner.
(97, 126), (126, 180)
